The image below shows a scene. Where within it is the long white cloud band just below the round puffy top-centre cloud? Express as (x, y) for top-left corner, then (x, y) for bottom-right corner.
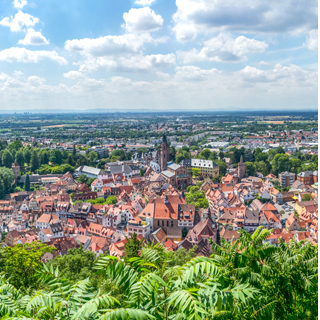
(65, 33), (167, 57)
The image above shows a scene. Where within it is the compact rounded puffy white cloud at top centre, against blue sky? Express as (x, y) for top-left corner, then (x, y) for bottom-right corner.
(123, 7), (163, 32)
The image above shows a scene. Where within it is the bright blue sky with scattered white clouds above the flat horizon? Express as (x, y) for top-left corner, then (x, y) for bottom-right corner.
(0, 0), (318, 111)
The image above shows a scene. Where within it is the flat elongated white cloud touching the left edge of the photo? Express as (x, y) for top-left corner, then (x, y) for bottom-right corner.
(0, 47), (68, 65)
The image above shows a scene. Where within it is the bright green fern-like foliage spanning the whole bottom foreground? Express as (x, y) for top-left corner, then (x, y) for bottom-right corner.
(0, 228), (318, 320)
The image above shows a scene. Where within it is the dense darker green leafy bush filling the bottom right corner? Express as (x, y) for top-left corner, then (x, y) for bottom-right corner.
(212, 226), (318, 319)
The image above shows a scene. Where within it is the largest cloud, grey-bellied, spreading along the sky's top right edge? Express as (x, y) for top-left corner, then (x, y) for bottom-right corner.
(172, 0), (318, 41)
